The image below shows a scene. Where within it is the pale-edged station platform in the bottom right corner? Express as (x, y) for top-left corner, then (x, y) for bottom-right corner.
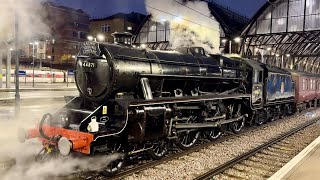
(269, 136), (320, 180)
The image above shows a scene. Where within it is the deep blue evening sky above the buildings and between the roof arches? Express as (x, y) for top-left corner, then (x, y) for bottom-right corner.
(52, 0), (267, 18)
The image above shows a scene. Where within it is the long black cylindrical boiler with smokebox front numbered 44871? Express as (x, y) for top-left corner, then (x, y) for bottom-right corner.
(75, 42), (240, 102)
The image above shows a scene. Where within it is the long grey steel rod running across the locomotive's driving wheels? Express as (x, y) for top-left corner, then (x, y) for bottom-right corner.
(175, 114), (248, 129)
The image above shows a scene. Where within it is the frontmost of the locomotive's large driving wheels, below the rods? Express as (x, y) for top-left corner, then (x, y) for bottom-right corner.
(176, 130), (200, 150)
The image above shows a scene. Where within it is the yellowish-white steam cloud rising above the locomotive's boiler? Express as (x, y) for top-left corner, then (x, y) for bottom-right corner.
(145, 0), (220, 53)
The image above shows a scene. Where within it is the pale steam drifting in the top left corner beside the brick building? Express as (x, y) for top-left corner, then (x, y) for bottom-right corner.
(0, 0), (50, 48)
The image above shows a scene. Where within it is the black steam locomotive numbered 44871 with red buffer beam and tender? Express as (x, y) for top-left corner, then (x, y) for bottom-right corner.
(21, 37), (294, 174)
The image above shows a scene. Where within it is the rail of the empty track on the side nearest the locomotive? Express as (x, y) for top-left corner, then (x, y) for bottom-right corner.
(195, 117), (320, 180)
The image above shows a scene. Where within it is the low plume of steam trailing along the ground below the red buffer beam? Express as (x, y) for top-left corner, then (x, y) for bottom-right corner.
(2, 154), (123, 180)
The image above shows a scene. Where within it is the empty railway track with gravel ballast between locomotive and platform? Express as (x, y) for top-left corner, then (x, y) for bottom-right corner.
(195, 118), (320, 180)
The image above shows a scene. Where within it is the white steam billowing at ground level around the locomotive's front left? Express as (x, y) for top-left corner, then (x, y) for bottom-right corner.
(0, 102), (122, 180)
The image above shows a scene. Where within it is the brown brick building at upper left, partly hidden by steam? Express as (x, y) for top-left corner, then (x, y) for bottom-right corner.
(20, 2), (90, 69)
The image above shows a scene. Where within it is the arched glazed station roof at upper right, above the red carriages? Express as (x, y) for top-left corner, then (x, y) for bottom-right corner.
(241, 0), (320, 73)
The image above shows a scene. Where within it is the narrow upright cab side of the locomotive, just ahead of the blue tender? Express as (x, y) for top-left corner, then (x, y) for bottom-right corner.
(252, 69), (263, 106)
